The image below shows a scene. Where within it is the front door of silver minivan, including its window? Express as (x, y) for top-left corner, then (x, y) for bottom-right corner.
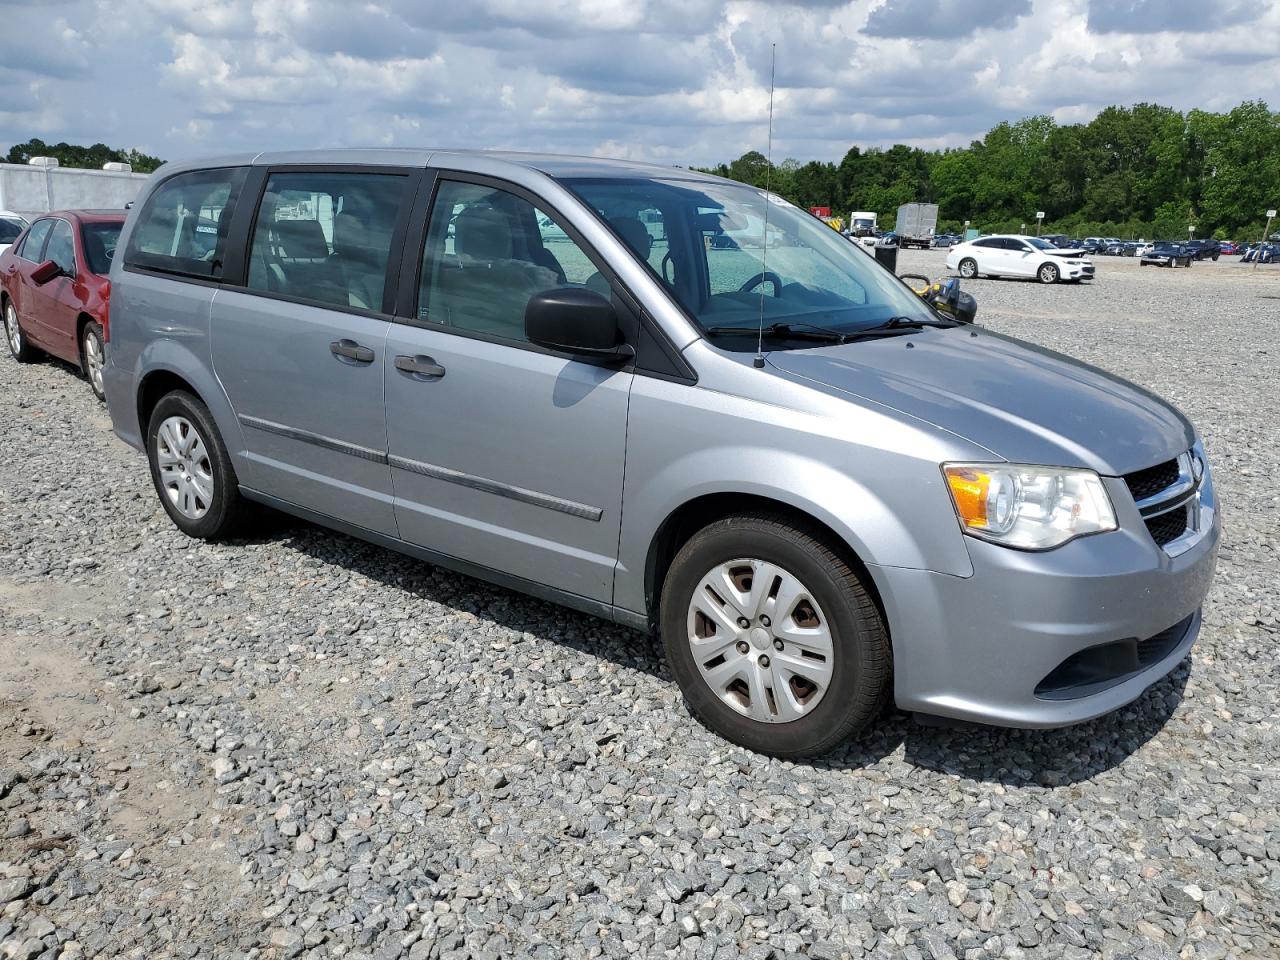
(384, 179), (632, 603)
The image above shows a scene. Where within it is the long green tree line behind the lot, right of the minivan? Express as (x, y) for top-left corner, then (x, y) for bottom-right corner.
(709, 100), (1280, 239)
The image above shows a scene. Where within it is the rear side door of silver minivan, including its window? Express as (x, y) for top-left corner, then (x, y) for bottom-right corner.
(211, 170), (415, 536)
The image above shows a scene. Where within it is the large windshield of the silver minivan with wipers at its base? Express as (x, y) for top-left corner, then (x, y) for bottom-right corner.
(566, 178), (937, 349)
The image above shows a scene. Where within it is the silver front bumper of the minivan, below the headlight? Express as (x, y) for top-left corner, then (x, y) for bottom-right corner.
(872, 475), (1221, 728)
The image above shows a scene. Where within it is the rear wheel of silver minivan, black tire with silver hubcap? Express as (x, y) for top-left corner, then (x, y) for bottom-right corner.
(147, 390), (248, 540)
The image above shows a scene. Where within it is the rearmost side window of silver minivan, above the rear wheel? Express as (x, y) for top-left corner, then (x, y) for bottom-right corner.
(124, 166), (244, 280)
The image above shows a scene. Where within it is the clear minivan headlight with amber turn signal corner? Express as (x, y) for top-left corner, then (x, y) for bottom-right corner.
(942, 463), (1116, 550)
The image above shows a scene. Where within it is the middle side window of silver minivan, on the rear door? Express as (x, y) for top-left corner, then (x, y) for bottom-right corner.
(248, 173), (408, 312)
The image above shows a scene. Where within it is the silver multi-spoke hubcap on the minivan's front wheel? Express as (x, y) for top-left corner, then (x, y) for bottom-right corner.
(687, 559), (835, 723)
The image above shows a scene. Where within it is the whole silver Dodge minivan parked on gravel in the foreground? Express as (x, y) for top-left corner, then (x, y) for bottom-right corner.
(105, 150), (1221, 756)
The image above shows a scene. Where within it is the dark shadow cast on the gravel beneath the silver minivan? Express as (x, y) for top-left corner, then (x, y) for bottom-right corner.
(232, 512), (1190, 787)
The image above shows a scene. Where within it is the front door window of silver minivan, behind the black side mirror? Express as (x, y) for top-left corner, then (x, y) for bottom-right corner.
(417, 180), (604, 340)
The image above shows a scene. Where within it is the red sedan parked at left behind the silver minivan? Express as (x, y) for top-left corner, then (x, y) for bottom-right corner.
(0, 210), (128, 399)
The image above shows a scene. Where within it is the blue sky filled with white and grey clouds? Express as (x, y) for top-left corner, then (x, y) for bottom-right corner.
(0, 0), (1280, 165)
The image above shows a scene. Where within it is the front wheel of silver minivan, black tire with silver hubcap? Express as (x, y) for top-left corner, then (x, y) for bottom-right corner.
(659, 513), (892, 758)
